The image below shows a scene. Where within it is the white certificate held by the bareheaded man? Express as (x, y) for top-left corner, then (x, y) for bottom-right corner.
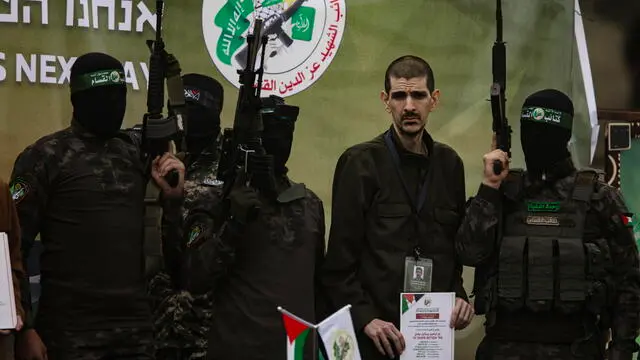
(400, 293), (455, 360)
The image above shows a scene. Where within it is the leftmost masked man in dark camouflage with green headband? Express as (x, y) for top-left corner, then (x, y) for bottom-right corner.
(11, 53), (184, 360)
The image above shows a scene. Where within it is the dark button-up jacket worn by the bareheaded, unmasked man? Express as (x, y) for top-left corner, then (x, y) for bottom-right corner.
(322, 128), (467, 359)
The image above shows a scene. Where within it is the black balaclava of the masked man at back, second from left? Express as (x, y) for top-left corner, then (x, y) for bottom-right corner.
(175, 74), (224, 154)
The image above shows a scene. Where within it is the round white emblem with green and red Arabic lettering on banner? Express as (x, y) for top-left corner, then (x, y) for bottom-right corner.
(202, 0), (346, 97)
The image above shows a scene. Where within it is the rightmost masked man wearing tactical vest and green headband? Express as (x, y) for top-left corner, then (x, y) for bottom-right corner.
(457, 89), (640, 360)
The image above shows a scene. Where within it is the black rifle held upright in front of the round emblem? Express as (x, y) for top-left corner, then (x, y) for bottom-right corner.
(218, 19), (267, 202)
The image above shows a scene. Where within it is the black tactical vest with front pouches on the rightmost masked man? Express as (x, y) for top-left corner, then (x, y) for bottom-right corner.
(475, 170), (609, 325)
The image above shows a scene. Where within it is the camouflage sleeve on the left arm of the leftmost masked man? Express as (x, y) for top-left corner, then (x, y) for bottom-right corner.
(10, 146), (52, 329)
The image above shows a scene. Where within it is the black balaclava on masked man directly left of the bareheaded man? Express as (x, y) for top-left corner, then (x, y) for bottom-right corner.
(262, 96), (300, 176)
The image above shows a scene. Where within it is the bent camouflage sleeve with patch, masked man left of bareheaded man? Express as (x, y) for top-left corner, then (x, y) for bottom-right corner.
(182, 211), (237, 294)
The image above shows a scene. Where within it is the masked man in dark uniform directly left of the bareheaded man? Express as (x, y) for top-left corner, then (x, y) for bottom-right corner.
(182, 97), (324, 360)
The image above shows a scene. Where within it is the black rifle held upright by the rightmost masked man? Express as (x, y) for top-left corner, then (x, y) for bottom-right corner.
(491, 0), (511, 175)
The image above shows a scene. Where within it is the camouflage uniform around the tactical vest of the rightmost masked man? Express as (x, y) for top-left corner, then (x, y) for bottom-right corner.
(456, 159), (640, 359)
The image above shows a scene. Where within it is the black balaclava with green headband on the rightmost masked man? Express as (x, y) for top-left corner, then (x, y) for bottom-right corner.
(520, 89), (573, 178)
